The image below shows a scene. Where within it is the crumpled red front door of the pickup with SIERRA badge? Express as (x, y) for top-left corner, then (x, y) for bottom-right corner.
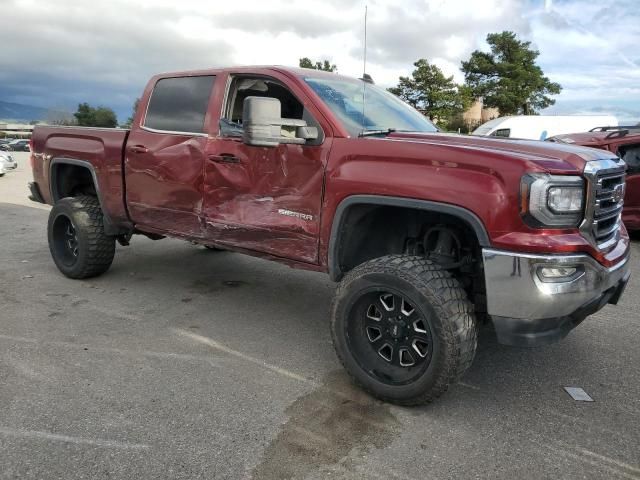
(204, 75), (331, 262)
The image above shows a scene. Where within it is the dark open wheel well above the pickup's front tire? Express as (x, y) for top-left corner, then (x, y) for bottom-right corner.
(330, 204), (486, 318)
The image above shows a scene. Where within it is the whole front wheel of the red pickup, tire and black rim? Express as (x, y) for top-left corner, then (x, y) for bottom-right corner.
(331, 255), (477, 405)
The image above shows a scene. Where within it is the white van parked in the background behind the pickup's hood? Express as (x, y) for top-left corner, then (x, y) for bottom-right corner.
(471, 115), (618, 140)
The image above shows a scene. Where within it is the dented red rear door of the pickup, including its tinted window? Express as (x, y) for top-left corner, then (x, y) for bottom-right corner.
(124, 75), (215, 237)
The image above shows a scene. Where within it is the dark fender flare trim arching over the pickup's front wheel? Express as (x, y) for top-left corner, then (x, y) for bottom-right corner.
(327, 195), (491, 282)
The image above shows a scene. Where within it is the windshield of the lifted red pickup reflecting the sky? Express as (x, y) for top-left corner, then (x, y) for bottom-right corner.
(304, 77), (438, 136)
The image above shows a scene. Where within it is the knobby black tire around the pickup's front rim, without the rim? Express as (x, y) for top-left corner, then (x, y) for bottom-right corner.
(331, 255), (478, 405)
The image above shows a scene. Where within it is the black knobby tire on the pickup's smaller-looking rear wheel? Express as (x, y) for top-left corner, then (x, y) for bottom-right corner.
(47, 196), (116, 279)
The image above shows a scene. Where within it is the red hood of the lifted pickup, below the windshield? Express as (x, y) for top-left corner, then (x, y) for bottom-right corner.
(385, 132), (616, 172)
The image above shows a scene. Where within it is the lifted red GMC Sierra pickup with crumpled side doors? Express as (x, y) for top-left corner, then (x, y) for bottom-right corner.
(30, 67), (629, 405)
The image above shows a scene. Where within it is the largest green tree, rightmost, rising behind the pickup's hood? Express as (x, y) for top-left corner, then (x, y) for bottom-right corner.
(462, 31), (562, 115)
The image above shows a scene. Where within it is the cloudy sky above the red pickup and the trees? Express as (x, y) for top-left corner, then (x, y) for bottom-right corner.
(0, 0), (640, 123)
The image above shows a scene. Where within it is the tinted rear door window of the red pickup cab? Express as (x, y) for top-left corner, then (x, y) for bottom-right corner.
(144, 75), (215, 133)
